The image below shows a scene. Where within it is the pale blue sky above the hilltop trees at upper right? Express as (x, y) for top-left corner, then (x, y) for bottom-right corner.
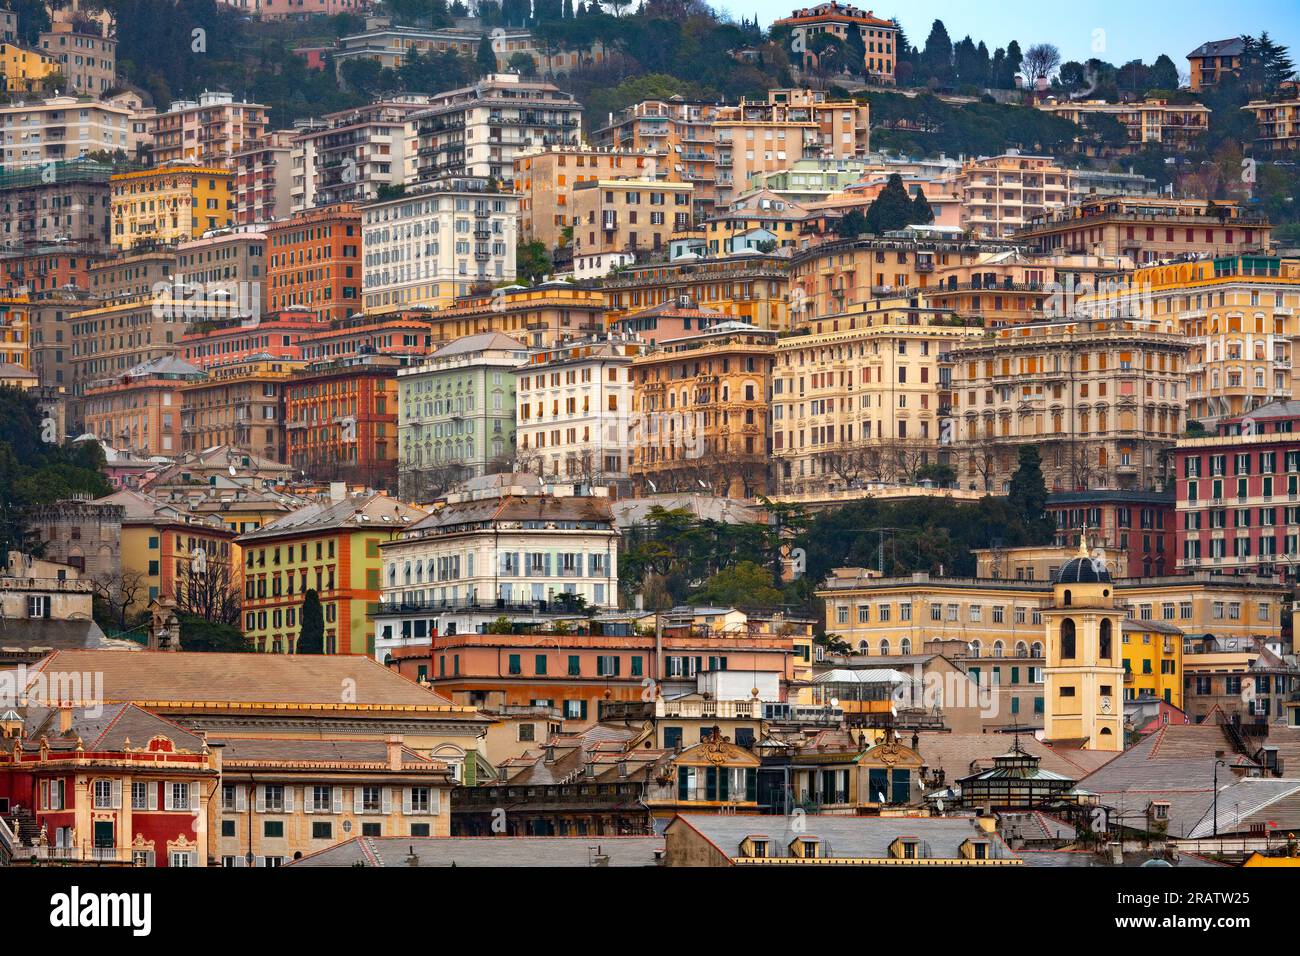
(728, 0), (1300, 73)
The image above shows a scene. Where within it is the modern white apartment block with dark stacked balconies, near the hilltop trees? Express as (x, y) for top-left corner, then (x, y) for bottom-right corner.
(412, 73), (582, 189)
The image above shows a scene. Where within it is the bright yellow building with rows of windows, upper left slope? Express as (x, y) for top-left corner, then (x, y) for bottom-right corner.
(109, 161), (235, 250)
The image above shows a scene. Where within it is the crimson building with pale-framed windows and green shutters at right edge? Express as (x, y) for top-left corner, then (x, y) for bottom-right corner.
(1174, 401), (1300, 579)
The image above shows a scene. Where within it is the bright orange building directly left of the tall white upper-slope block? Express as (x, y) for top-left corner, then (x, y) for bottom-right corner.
(267, 203), (361, 319)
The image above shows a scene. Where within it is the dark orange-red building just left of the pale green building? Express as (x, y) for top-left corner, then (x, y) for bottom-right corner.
(285, 354), (403, 488)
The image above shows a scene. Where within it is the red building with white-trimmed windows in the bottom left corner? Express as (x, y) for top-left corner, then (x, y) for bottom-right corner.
(0, 702), (220, 866)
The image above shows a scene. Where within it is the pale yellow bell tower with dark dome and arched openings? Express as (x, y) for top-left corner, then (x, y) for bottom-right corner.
(1043, 535), (1125, 750)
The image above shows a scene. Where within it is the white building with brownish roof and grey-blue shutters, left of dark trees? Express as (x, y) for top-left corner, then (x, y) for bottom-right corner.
(373, 475), (619, 661)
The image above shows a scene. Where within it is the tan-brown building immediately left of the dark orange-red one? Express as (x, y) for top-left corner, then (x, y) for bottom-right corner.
(181, 356), (303, 462)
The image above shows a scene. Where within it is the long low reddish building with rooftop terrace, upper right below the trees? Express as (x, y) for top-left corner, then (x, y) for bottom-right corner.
(1017, 196), (1273, 265)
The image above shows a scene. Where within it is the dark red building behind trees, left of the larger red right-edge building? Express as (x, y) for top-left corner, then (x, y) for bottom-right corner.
(1048, 490), (1177, 578)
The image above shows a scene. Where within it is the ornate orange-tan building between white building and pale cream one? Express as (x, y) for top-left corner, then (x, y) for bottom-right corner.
(631, 321), (776, 497)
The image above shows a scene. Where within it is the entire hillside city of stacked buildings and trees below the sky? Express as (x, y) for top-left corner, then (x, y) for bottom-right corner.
(0, 0), (1300, 889)
